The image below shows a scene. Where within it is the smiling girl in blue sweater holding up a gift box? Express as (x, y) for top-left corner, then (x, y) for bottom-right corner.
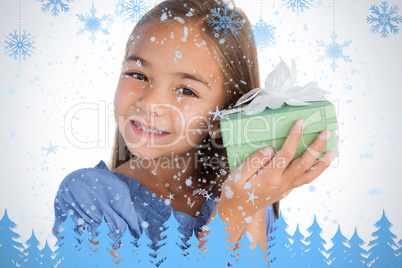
(53, 0), (336, 264)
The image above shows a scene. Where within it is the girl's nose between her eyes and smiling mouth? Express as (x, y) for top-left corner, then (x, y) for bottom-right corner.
(135, 84), (166, 116)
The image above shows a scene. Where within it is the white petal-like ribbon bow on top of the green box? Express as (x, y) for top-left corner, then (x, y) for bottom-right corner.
(222, 58), (327, 116)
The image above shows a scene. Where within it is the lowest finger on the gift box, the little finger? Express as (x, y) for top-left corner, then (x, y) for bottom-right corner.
(289, 151), (336, 189)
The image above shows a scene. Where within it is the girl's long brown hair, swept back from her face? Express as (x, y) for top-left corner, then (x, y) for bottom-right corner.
(107, 0), (279, 217)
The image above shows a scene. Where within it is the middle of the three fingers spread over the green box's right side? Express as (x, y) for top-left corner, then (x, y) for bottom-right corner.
(283, 130), (331, 180)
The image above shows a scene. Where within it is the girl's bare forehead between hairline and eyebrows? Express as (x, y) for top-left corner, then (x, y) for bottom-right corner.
(128, 23), (221, 74)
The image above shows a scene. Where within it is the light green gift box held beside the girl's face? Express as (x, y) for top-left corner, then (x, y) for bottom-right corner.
(220, 100), (338, 171)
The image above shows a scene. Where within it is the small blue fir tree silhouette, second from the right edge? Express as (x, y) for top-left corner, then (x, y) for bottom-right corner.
(346, 227), (367, 268)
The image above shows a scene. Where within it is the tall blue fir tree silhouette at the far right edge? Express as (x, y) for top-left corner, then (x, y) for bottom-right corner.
(368, 210), (400, 268)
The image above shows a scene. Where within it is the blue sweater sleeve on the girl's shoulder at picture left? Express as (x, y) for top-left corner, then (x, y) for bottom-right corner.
(52, 168), (141, 248)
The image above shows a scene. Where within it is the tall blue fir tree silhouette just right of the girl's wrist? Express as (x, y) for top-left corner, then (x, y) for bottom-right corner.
(267, 211), (290, 268)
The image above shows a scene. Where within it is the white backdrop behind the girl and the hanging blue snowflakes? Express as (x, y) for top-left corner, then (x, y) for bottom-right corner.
(0, 0), (402, 251)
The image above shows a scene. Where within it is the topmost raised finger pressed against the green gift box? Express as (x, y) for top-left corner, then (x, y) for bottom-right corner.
(272, 119), (305, 172)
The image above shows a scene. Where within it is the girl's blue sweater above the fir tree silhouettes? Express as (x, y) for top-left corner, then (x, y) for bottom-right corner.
(52, 160), (276, 248)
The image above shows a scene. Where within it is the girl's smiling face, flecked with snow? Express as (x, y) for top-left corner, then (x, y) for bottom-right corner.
(115, 23), (224, 158)
